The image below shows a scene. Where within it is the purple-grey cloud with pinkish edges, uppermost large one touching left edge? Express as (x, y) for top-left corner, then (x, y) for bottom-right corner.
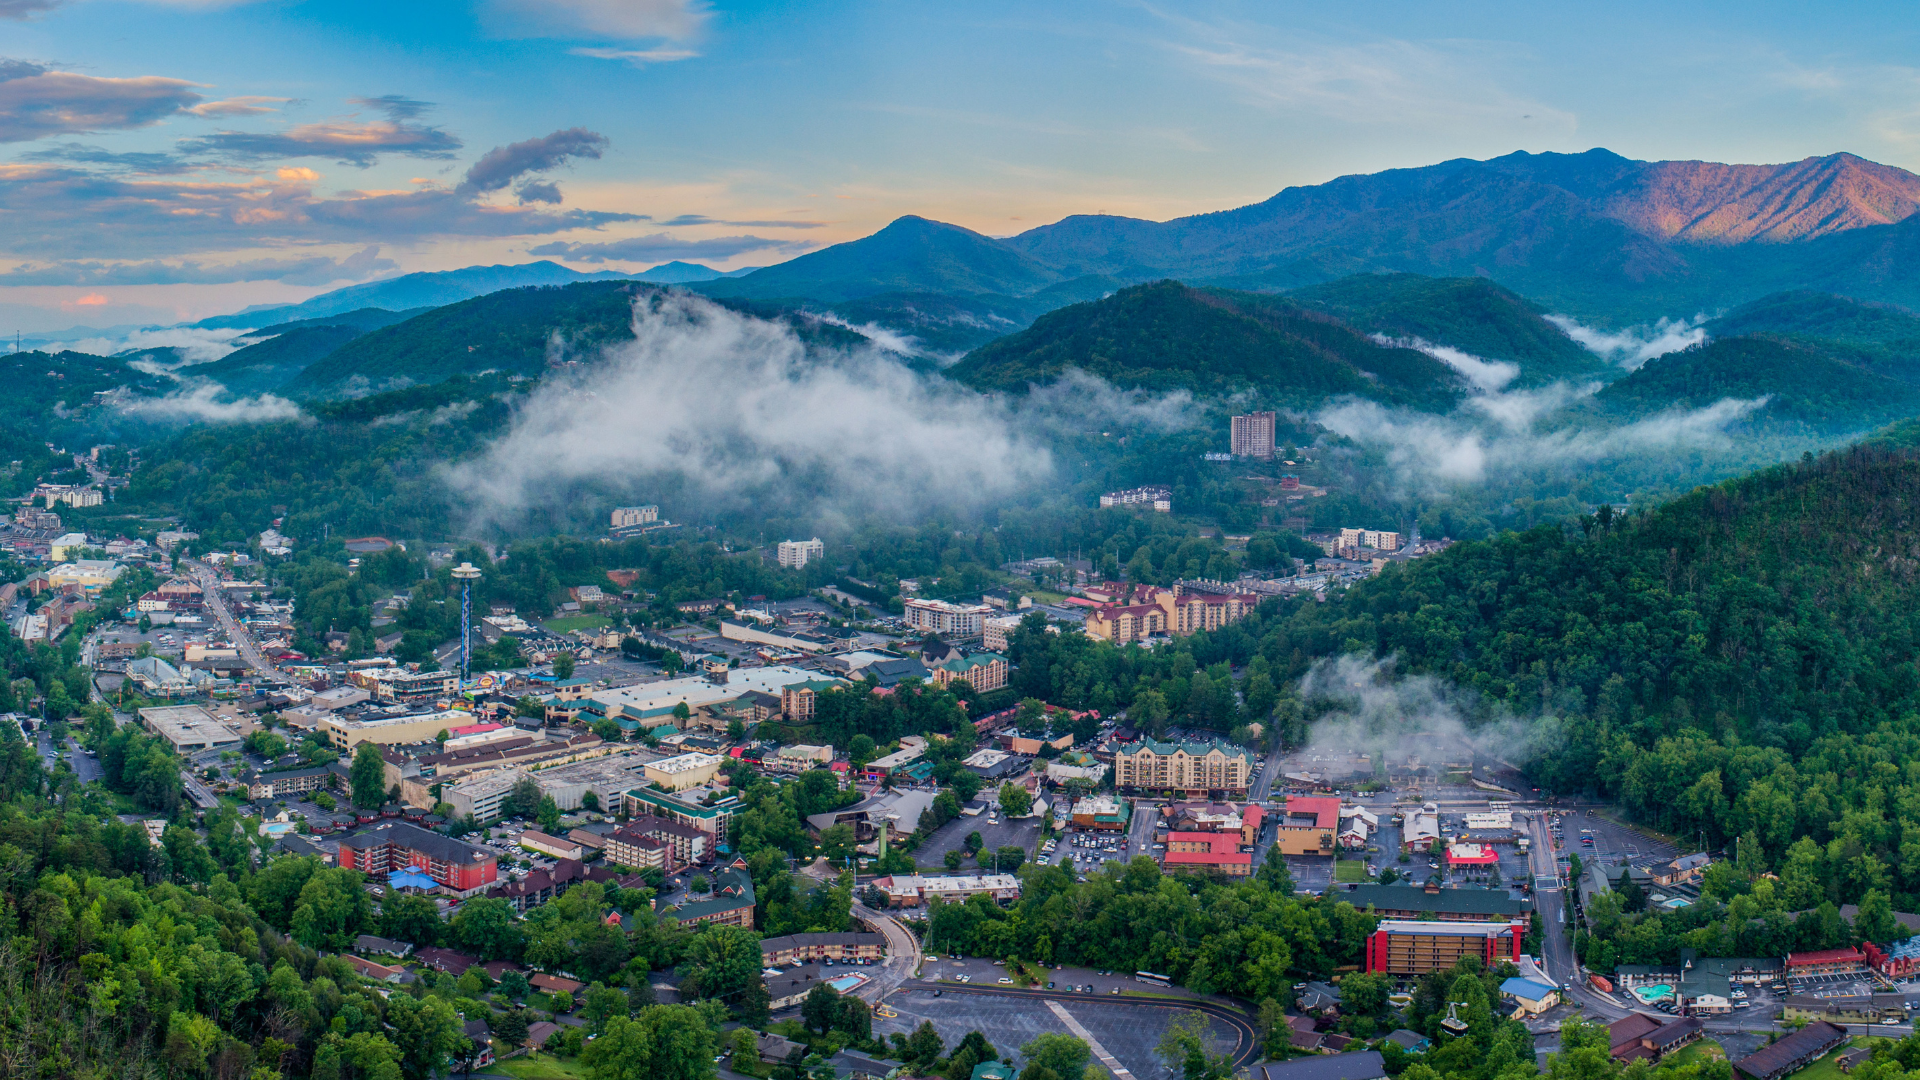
(0, 60), (202, 142)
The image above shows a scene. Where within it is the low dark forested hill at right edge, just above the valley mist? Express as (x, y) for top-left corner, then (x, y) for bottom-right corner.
(1596, 334), (1920, 432)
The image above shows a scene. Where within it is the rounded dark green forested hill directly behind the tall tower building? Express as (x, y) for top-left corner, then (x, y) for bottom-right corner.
(948, 281), (1459, 404)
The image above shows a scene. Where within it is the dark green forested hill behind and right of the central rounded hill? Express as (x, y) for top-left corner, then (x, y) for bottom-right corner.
(1286, 273), (1603, 384)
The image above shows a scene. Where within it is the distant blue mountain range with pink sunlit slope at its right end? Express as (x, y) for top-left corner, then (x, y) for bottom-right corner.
(695, 150), (1920, 323)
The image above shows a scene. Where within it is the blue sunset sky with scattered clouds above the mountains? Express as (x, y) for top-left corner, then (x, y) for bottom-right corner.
(0, 0), (1920, 332)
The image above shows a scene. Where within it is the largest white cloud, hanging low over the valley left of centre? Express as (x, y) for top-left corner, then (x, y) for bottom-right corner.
(447, 286), (1052, 521)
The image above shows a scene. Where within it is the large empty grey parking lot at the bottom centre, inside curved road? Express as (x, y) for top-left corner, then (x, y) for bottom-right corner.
(874, 980), (1238, 1080)
